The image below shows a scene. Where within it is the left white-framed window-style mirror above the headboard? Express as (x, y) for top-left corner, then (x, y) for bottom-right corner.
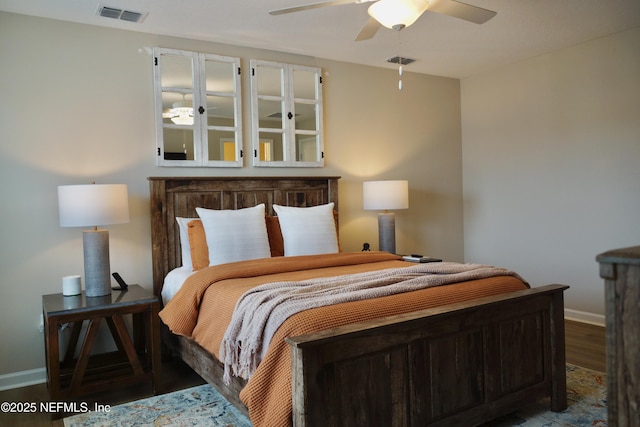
(153, 48), (243, 167)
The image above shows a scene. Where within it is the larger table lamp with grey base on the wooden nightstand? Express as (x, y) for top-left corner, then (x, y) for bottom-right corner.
(58, 184), (129, 297)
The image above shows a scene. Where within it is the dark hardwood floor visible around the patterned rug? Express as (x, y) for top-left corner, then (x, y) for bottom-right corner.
(0, 320), (606, 427)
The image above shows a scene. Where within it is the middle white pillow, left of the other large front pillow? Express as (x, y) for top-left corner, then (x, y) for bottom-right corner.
(196, 204), (271, 265)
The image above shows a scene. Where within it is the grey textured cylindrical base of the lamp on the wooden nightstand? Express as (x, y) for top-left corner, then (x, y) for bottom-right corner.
(82, 230), (111, 297)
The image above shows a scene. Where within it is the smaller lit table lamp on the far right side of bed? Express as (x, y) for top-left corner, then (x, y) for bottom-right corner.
(362, 181), (409, 254)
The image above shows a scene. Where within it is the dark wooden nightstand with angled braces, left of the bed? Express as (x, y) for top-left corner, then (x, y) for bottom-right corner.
(42, 285), (161, 401)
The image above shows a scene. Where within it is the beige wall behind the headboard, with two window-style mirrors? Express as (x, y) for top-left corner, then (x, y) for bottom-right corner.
(0, 13), (463, 380)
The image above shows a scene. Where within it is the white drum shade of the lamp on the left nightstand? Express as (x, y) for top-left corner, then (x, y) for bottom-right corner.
(58, 184), (129, 227)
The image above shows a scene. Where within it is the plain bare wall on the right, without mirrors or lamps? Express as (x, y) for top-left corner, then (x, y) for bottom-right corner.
(461, 28), (640, 321)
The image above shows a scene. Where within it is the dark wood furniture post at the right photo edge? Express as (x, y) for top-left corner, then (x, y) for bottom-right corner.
(596, 246), (640, 427)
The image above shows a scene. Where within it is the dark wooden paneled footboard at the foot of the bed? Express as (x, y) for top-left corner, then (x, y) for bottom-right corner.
(287, 285), (567, 427)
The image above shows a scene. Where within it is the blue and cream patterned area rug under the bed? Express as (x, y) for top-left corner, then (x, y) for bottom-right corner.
(64, 365), (607, 427)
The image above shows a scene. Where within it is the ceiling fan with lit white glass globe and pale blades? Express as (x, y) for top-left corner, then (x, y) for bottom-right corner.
(269, 0), (496, 41)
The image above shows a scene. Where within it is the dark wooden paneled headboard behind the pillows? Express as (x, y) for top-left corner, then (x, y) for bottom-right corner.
(149, 177), (340, 296)
